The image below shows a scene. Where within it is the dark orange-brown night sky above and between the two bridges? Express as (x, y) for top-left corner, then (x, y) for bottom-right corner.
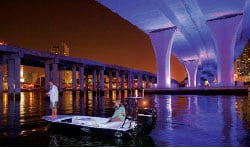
(0, 0), (186, 81)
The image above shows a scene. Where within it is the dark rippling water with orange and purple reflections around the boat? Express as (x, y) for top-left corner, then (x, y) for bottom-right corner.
(0, 92), (250, 147)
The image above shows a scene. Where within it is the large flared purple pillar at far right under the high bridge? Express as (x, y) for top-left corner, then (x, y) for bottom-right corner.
(207, 15), (242, 86)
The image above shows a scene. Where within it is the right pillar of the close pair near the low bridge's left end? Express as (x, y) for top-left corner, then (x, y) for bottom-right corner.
(15, 57), (21, 94)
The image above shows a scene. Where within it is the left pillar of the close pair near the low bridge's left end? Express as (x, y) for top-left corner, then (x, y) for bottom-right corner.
(8, 59), (15, 94)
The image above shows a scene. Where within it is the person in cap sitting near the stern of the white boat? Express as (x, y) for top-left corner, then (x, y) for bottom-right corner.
(108, 100), (126, 122)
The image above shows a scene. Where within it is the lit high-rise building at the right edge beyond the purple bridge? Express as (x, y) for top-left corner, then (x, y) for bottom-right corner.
(236, 40), (250, 81)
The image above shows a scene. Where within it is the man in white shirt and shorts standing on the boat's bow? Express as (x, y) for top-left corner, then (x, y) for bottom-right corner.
(46, 81), (58, 118)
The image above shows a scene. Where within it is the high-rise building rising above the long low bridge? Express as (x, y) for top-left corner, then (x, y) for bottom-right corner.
(51, 42), (69, 56)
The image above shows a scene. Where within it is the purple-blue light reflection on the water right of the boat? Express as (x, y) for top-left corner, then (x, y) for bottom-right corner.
(151, 95), (250, 146)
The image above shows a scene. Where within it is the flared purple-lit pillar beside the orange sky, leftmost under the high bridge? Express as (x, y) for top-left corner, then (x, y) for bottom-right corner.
(149, 28), (176, 88)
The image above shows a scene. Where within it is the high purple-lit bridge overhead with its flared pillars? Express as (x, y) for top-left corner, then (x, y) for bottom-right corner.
(98, 0), (250, 88)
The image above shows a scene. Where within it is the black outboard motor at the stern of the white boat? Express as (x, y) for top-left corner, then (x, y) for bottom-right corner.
(137, 108), (157, 135)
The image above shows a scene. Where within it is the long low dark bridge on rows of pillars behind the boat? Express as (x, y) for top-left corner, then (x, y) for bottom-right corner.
(0, 45), (156, 95)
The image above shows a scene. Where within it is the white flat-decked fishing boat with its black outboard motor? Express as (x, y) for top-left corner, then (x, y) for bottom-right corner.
(42, 109), (155, 138)
